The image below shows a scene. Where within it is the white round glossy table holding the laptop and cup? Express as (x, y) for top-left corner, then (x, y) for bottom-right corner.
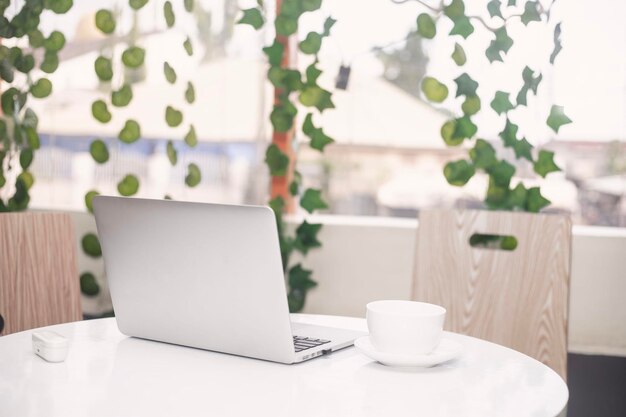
(0, 315), (568, 417)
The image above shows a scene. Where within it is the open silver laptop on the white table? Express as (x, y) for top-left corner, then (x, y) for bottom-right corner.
(93, 196), (363, 364)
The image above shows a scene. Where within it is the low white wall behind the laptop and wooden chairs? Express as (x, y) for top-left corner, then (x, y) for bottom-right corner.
(66, 213), (626, 356)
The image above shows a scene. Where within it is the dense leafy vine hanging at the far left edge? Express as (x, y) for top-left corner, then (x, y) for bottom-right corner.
(0, 0), (73, 212)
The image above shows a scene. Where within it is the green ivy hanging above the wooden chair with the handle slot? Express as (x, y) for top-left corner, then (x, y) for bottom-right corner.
(404, 0), (571, 212)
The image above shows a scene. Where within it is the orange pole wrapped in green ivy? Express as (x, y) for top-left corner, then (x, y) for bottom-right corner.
(270, 0), (296, 213)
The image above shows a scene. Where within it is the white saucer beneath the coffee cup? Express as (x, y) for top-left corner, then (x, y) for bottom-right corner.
(354, 336), (463, 368)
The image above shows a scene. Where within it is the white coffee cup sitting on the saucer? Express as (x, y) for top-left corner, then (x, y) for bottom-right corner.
(367, 300), (446, 355)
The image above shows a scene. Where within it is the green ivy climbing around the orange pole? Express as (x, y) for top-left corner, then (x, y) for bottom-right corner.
(238, 0), (335, 312)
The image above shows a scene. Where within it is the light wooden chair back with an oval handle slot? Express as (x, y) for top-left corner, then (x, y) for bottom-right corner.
(412, 210), (571, 379)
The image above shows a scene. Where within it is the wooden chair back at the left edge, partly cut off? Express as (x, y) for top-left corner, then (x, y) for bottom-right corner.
(0, 212), (82, 335)
